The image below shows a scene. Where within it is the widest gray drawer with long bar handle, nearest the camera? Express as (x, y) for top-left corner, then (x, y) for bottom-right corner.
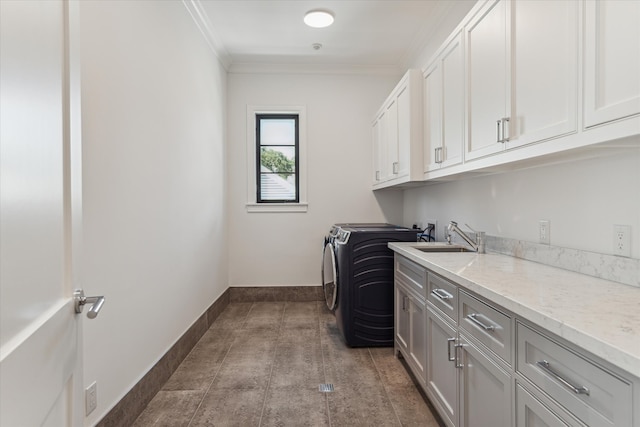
(516, 323), (633, 427)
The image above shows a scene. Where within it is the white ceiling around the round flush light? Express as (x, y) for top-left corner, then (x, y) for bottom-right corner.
(190, 0), (464, 72)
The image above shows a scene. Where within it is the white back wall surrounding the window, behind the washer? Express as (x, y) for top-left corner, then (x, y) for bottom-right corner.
(228, 74), (402, 286)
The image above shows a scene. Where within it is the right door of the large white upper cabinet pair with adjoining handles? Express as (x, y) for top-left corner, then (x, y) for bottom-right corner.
(506, 0), (580, 148)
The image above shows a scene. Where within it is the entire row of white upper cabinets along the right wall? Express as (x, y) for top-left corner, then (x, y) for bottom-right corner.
(373, 0), (640, 189)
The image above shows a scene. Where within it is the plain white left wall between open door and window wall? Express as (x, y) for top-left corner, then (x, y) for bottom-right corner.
(80, 1), (228, 425)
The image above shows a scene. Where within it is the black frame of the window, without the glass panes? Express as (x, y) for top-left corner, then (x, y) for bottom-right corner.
(255, 113), (300, 204)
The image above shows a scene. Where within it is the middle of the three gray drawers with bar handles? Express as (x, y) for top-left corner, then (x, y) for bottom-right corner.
(459, 292), (511, 364)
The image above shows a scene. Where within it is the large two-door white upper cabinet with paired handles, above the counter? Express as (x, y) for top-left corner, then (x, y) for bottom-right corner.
(466, 0), (579, 160)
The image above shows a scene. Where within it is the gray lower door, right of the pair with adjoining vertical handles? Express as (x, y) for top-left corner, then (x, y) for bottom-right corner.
(459, 334), (513, 427)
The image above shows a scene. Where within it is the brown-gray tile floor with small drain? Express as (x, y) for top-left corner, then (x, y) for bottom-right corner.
(134, 301), (439, 427)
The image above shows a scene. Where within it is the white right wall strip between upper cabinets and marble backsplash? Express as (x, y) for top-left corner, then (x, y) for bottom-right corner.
(404, 149), (640, 258)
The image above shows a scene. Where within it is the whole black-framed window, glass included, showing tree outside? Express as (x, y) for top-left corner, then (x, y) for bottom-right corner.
(256, 114), (300, 203)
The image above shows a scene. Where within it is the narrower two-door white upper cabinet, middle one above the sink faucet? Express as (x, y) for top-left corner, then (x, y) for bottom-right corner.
(422, 32), (465, 172)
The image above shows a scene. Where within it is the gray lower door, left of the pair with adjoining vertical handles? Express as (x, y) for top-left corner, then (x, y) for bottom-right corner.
(426, 305), (458, 427)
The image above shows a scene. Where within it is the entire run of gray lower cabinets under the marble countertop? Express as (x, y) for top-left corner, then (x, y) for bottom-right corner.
(395, 255), (640, 427)
